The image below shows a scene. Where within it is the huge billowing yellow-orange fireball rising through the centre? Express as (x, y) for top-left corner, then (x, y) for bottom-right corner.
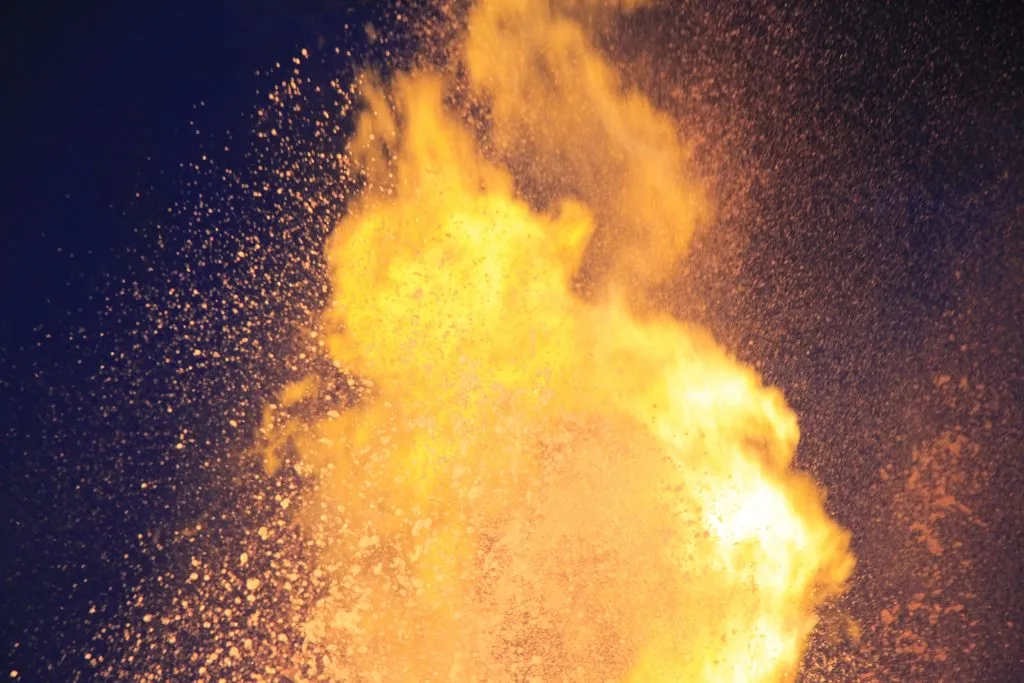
(260, 0), (853, 683)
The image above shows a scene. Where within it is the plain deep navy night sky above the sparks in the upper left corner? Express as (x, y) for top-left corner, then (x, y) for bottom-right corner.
(2, 0), (368, 345)
